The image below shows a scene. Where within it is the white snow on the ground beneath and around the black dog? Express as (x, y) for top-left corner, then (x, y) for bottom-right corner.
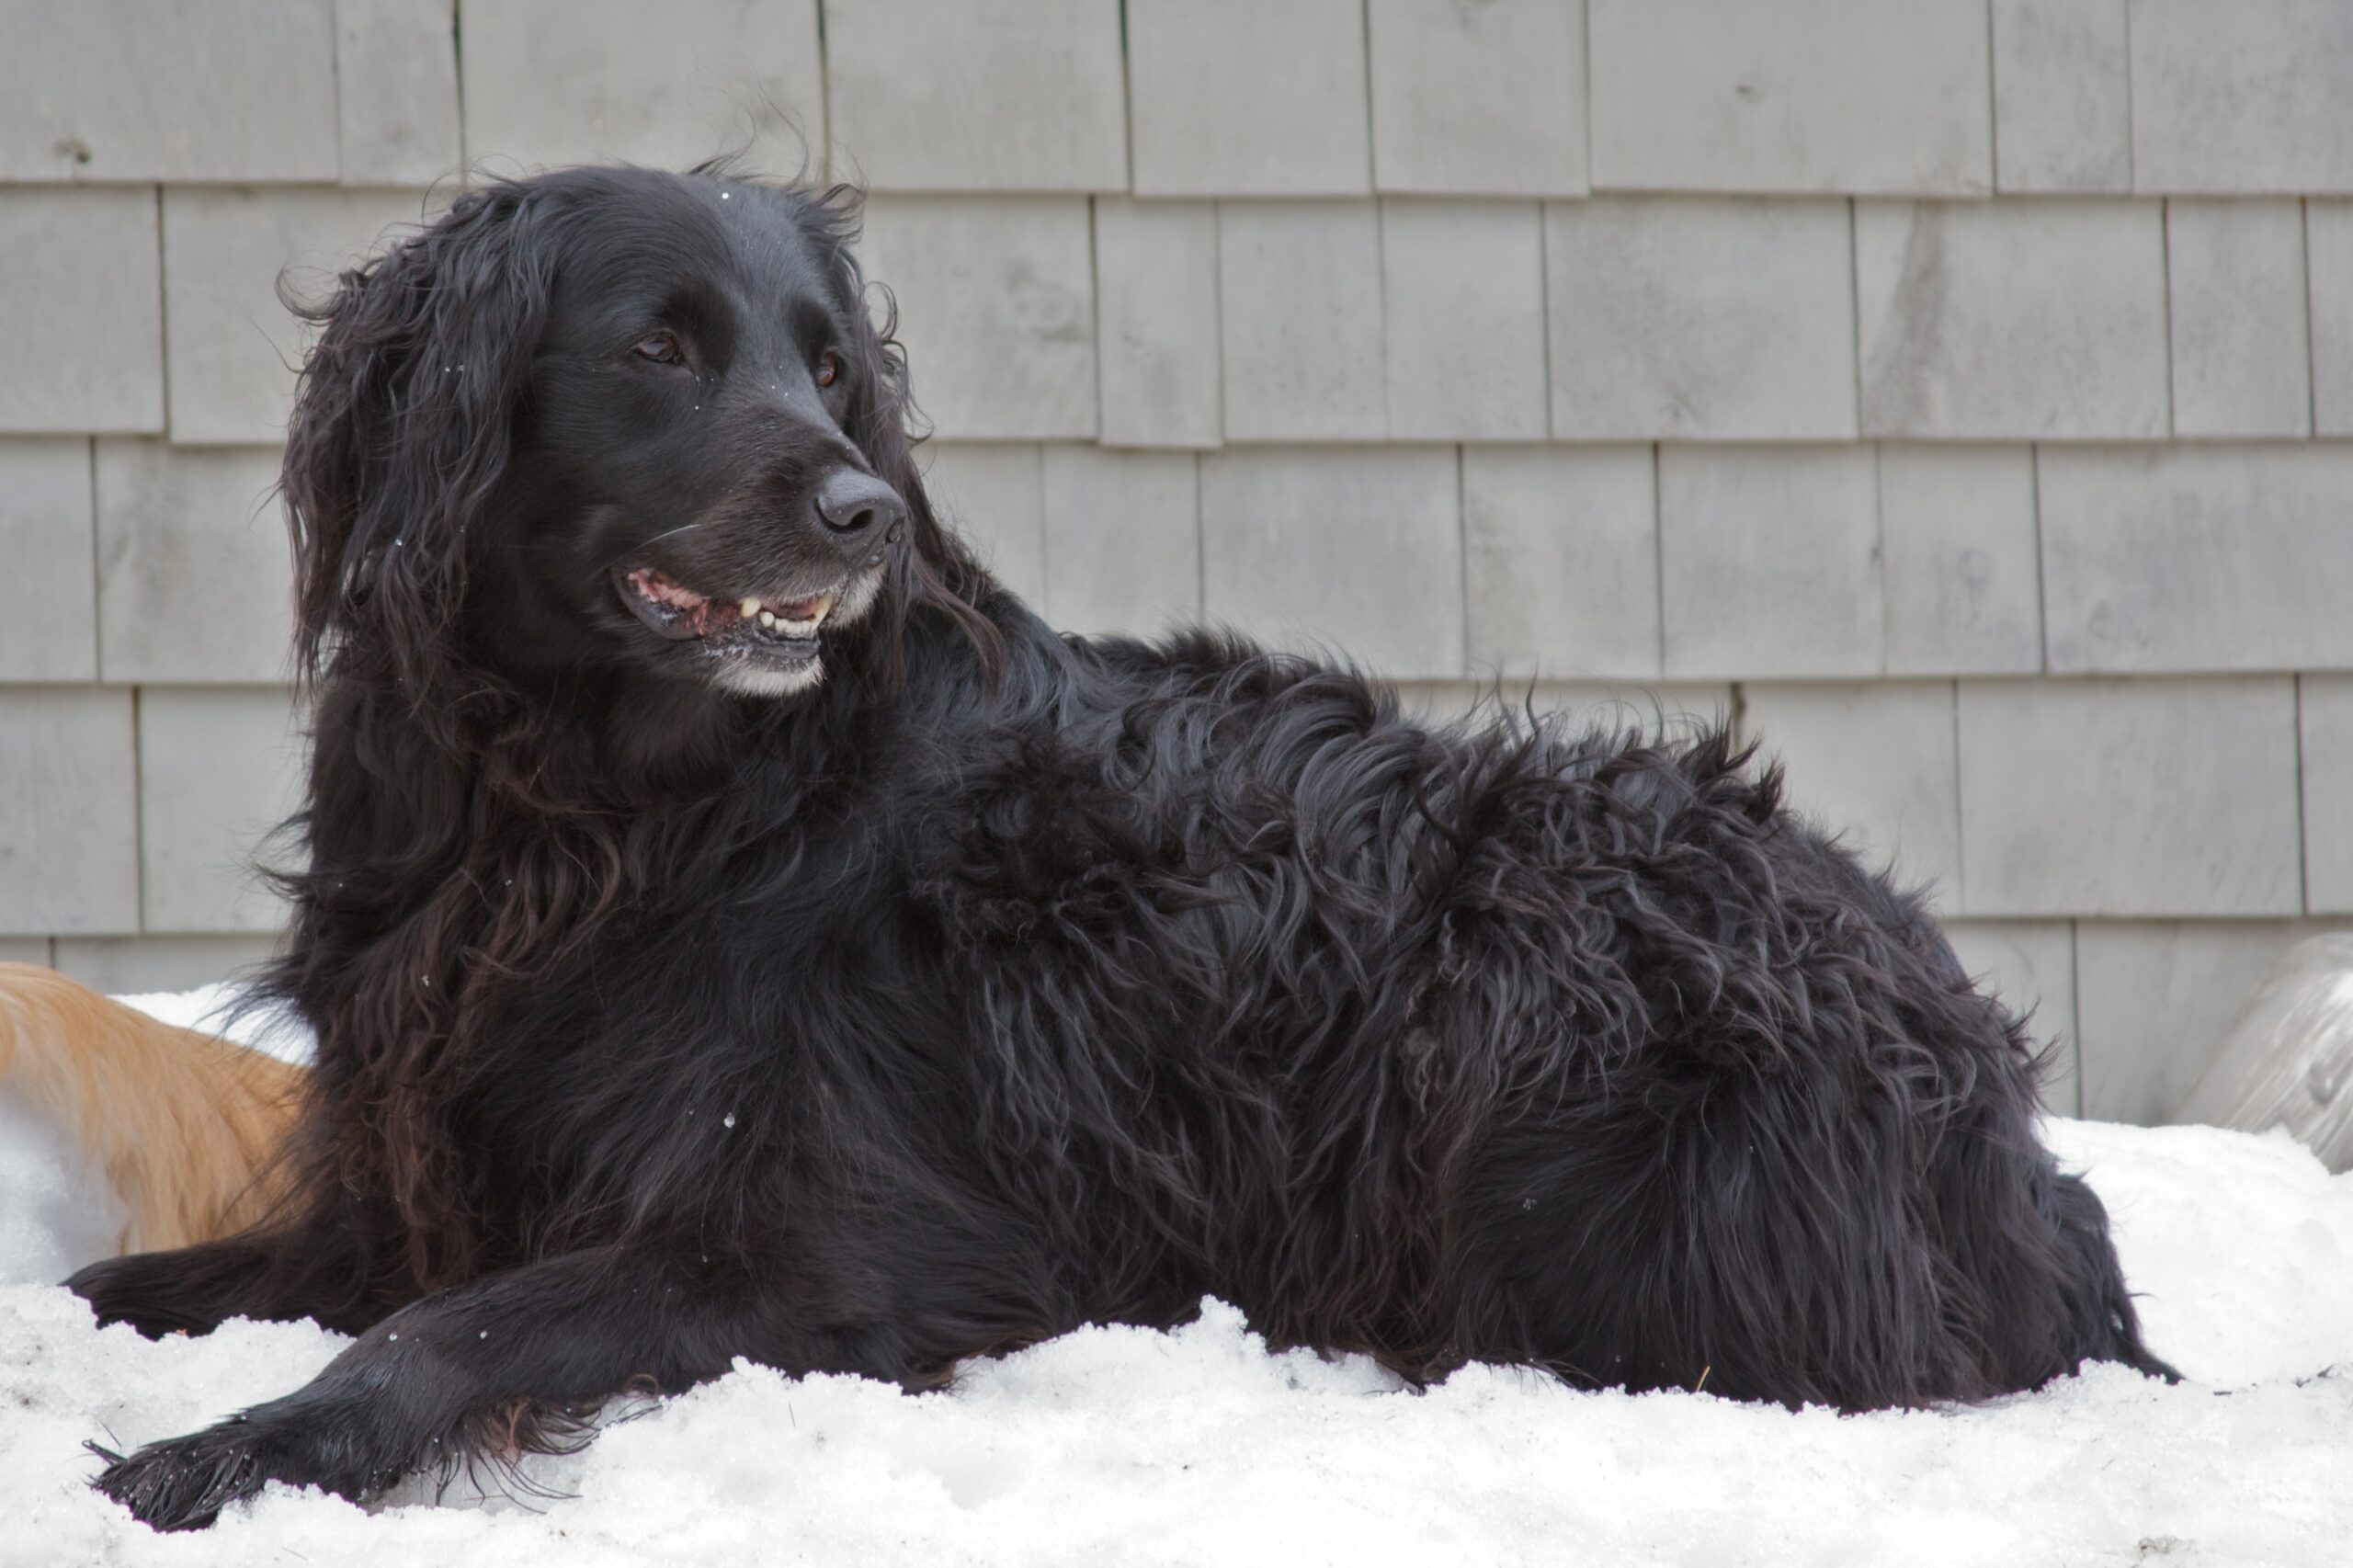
(0, 998), (2353, 1568)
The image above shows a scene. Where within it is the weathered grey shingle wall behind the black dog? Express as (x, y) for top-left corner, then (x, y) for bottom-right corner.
(0, 0), (2353, 1119)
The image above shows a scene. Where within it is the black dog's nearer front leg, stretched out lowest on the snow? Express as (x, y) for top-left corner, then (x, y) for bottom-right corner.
(97, 1248), (901, 1530)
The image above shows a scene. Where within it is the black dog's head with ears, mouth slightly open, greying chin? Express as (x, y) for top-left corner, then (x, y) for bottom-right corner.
(282, 169), (983, 697)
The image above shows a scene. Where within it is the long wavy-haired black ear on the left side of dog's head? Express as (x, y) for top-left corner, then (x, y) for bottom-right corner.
(280, 181), (551, 690)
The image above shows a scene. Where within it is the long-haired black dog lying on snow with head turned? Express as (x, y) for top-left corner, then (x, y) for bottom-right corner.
(73, 169), (2165, 1528)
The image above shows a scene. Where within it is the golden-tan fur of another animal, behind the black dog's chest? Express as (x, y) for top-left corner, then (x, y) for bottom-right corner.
(0, 963), (303, 1253)
